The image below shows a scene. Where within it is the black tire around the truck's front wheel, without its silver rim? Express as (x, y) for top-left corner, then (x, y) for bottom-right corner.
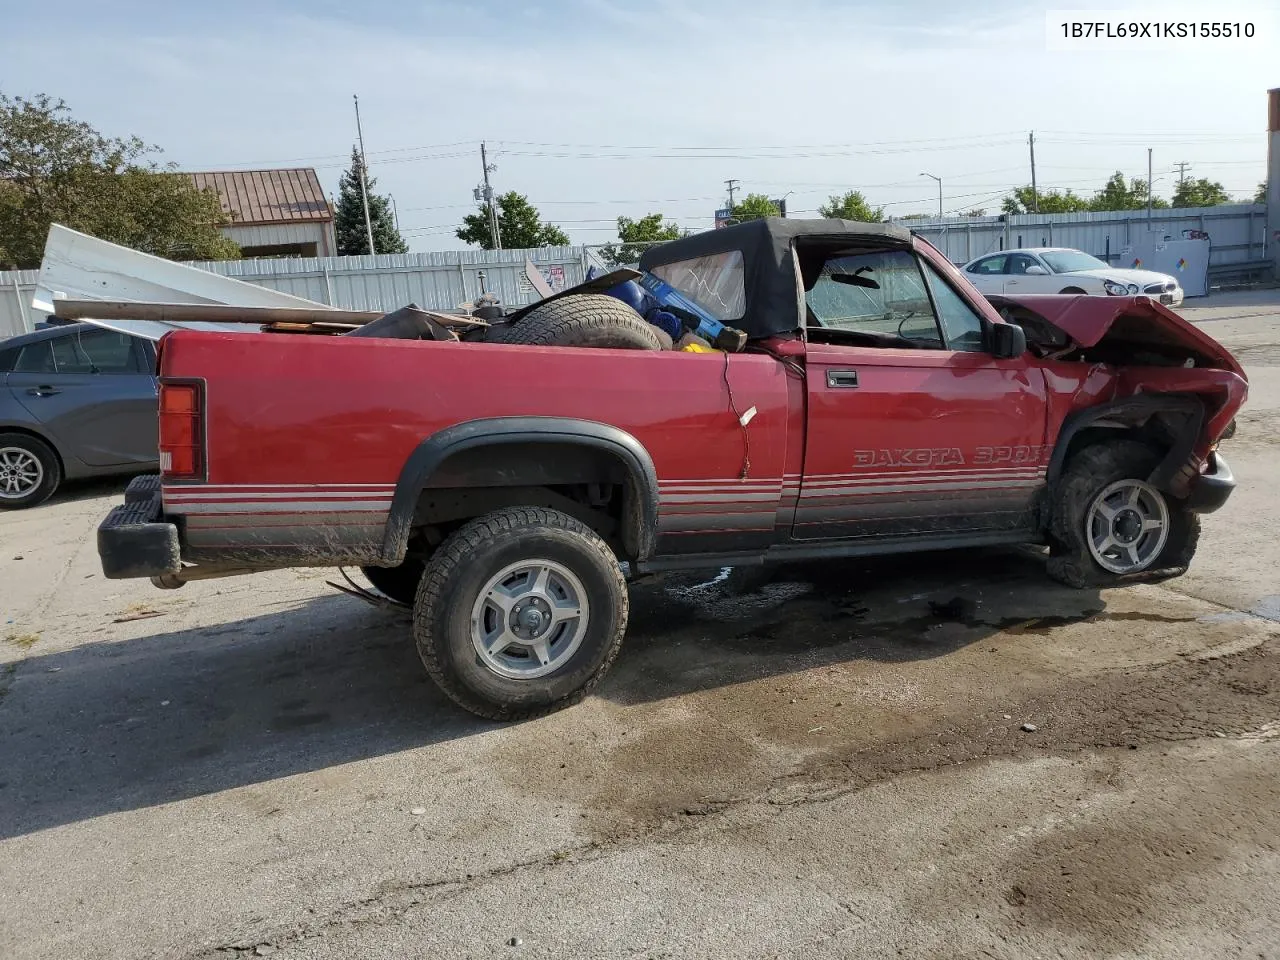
(1048, 439), (1201, 589)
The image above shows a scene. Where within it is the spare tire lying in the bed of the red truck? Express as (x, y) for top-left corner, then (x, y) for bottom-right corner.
(502, 293), (663, 349)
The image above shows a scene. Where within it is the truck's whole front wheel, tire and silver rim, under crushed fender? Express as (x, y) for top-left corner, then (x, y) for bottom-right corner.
(1048, 440), (1199, 588)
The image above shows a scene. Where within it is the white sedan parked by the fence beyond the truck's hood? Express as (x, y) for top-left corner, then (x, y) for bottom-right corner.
(964, 247), (1183, 305)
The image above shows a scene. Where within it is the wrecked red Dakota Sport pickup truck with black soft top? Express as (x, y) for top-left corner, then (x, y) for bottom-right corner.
(99, 219), (1247, 719)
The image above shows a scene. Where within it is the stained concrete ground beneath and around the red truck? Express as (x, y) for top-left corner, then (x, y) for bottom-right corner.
(0, 292), (1280, 960)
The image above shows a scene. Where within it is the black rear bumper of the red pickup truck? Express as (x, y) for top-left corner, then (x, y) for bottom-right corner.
(97, 477), (182, 580)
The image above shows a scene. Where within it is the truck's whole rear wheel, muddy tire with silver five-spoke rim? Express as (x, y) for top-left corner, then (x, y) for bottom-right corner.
(413, 507), (627, 721)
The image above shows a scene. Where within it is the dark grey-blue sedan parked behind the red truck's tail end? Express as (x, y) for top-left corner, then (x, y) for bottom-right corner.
(0, 324), (159, 509)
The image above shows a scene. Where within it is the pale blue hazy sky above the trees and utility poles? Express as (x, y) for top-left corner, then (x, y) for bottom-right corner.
(0, 0), (1280, 250)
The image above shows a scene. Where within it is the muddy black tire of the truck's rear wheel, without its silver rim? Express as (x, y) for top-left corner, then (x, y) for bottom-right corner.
(413, 507), (628, 721)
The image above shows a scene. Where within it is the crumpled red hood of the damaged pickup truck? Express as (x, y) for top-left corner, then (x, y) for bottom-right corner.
(987, 294), (1244, 376)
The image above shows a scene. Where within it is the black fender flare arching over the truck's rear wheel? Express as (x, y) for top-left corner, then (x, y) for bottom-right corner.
(381, 416), (658, 566)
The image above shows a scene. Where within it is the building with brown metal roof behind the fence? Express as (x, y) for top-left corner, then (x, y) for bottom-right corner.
(187, 166), (338, 257)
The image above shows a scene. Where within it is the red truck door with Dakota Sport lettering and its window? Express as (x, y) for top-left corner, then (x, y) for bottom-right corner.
(792, 248), (1047, 545)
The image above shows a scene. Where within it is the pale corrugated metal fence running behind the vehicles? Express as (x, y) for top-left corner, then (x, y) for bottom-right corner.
(0, 204), (1267, 338)
